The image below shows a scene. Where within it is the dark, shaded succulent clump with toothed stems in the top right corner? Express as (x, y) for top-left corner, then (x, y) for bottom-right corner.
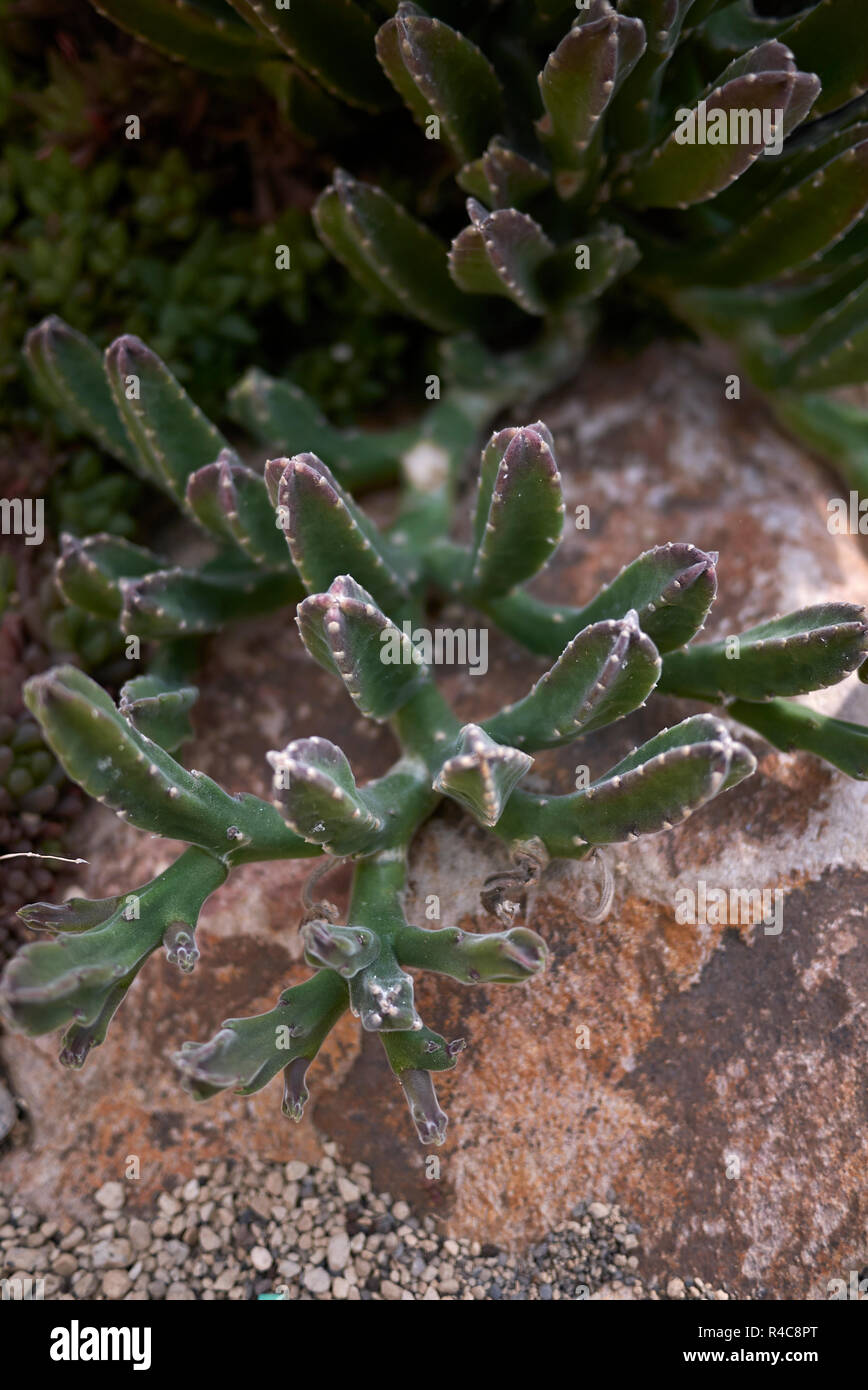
(77, 0), (868, 492)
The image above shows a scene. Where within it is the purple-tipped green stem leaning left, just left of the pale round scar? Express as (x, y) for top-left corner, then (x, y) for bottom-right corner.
(277, 453), (409, 614)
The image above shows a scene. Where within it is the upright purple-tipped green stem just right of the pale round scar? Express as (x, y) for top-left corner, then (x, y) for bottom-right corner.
(469, 424), (563, 598)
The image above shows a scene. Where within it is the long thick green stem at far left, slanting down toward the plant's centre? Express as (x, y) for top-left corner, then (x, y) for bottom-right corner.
(24, 666), (315, 863)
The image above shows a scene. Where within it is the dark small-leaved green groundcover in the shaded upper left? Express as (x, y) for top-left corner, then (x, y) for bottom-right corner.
(0, 24), (426, 432)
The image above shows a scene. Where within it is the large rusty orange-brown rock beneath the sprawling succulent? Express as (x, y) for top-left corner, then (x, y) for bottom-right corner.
(0, 345), (868, 1297)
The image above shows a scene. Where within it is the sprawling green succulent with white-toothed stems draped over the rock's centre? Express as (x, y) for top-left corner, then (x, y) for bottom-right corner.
(0, 403), (868, 1143)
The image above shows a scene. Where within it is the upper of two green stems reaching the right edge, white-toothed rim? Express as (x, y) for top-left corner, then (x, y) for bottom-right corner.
(659, 603), (868, 699)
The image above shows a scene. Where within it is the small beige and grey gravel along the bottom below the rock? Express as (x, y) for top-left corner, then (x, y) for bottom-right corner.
(0, 1144), (729, 1302)
